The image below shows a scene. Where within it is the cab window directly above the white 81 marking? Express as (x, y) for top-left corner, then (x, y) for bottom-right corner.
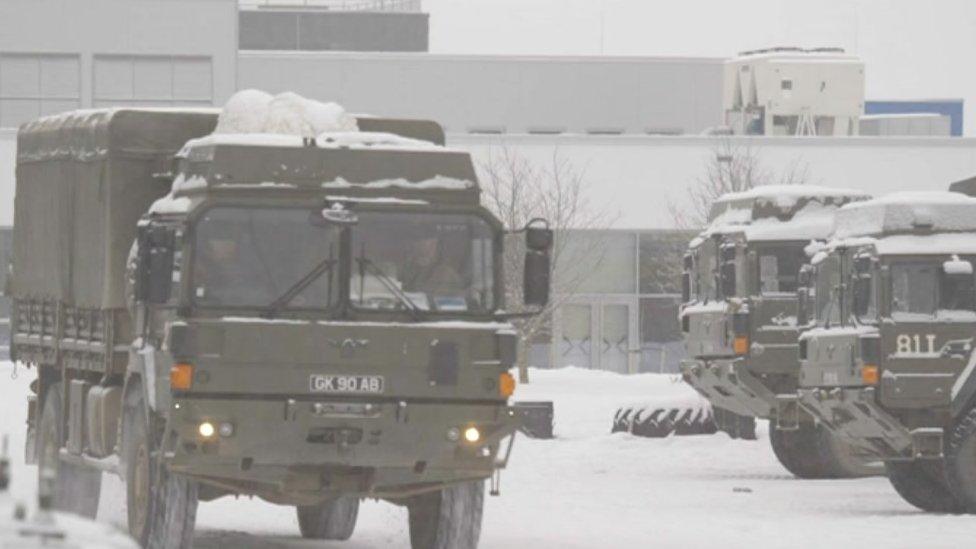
(891, 261), (976, 321)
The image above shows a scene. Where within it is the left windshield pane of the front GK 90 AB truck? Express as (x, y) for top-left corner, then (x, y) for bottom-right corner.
(192, 207), (339, 310)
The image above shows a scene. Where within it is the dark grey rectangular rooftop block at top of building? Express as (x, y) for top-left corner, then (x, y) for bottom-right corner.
(240, 9), (430, 52)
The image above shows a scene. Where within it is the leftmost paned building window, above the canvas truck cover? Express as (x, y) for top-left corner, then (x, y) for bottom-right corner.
(0, 53), (81, 128)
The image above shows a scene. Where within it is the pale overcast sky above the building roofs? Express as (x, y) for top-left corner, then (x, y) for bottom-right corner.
(424, 0), (976, 135)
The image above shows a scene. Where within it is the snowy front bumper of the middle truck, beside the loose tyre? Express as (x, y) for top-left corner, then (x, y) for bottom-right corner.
(681, 358), (777, 418)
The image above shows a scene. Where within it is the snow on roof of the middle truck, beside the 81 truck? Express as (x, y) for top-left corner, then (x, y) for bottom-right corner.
(691, 185), (870, 247)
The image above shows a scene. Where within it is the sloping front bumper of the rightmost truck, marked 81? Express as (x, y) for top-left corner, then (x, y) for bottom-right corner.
(799, 387), (928, 459)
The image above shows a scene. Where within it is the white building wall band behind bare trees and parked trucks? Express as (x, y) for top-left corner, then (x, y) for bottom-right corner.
(447, 134), (976, 229)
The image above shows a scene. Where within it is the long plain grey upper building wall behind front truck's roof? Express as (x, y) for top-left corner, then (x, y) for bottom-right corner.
(238, 52), (722, 134)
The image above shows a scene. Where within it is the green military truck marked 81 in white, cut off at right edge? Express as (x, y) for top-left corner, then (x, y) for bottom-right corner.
(798, 192), (976, 512)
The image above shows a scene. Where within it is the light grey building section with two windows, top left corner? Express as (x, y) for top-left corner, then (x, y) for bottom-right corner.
(0, 0), (237, 127)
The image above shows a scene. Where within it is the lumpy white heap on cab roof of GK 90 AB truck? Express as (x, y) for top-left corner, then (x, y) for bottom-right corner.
(214, 90), (359, 137)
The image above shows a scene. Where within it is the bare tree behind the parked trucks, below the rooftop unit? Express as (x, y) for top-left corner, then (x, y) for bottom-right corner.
(668, 137), (810, 229)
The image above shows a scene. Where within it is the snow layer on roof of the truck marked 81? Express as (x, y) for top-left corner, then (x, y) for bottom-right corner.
(833, 191), (976, 239)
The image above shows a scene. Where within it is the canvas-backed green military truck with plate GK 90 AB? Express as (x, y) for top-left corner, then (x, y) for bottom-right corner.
(11, 105), (552, 548)
